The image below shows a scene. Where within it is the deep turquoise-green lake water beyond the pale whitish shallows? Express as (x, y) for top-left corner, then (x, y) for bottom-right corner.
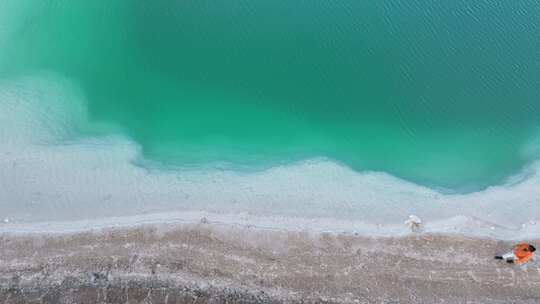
(0, 0), (540, 191)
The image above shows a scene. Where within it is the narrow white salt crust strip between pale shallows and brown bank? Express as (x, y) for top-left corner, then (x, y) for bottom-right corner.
(0, 211), (540, 241)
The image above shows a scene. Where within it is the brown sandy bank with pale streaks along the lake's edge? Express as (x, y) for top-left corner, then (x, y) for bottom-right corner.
(0, 223), (540, 303)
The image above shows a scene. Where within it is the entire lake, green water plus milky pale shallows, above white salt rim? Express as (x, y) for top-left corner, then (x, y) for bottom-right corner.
(0, 0), (540, 233)
